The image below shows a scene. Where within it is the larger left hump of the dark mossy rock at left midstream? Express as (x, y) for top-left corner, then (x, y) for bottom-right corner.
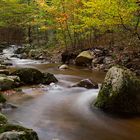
(12, 68), (44, 84)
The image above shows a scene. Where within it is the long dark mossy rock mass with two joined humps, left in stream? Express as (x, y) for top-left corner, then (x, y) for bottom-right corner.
(12, 68), (58, 84)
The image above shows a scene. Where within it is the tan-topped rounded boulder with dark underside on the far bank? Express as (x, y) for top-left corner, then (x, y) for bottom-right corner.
(75, 51), (93, 66)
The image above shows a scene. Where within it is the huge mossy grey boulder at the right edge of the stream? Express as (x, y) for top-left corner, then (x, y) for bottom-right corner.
(92, 66), (140, 113)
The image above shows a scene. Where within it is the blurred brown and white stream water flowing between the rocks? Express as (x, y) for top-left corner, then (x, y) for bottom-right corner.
(1, 46), (140, 140)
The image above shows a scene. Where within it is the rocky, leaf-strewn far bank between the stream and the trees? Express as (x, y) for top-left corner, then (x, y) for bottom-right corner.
(15, 46), (140, 76)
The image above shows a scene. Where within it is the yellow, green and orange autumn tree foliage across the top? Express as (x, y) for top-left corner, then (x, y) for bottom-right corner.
(0, 0), (140, 47)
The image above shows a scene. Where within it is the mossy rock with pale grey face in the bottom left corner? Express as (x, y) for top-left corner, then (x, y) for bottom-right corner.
(0, 124), (39, 140)
